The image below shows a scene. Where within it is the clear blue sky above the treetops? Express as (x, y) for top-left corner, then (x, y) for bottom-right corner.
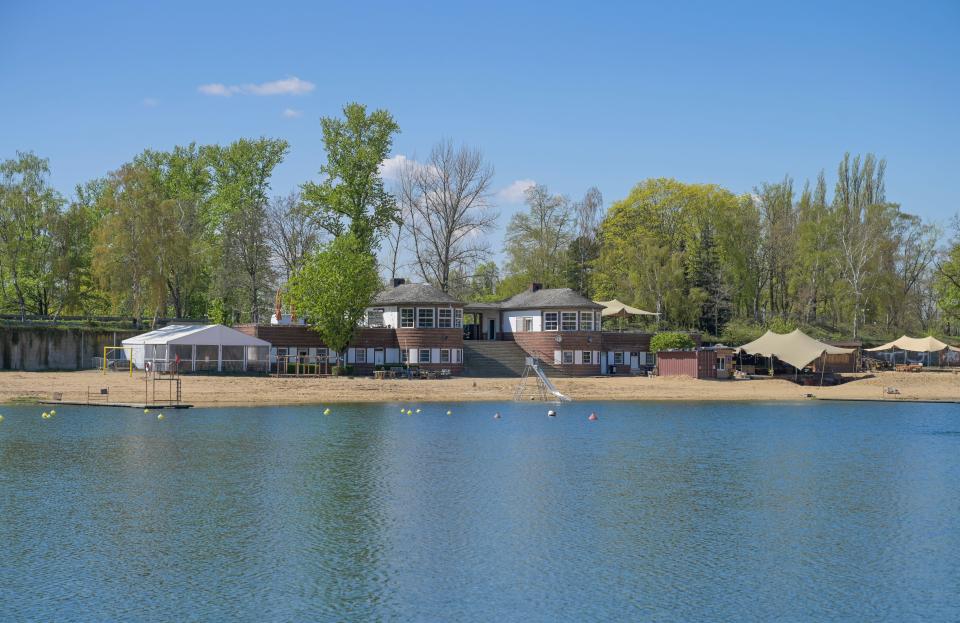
(0, 0), (960, 256)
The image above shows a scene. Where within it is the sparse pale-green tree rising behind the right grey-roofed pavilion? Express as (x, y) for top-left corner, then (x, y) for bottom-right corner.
(505, 184), (574, 287)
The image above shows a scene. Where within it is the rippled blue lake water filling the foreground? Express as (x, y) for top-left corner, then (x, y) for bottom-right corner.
(0, 403), (960, 622)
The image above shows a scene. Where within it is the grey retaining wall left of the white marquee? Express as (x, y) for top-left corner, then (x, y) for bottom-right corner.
(0, 327), (139, 371)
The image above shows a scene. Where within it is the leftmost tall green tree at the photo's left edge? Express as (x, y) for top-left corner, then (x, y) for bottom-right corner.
(0, 152), (63, 317)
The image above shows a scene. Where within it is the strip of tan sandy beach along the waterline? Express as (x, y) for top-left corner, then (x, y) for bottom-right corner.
(0, 371), (960, 406)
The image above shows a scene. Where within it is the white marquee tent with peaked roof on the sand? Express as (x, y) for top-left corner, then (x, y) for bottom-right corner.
(123, 324), (270, 372)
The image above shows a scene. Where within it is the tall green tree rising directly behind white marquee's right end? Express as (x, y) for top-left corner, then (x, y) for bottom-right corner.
(206, 138), (289, 322)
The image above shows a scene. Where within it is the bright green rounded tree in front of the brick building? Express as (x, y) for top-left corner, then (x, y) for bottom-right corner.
(289, 233), (381, 364)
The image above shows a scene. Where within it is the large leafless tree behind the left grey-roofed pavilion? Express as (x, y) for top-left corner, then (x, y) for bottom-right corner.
(400, 141), (497, 292)
